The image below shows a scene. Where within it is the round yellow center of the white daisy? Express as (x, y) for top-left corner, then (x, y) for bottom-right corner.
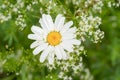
(47, 31), (62, 46)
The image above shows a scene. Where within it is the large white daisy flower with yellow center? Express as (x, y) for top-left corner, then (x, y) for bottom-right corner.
(28, 14), (81, 64)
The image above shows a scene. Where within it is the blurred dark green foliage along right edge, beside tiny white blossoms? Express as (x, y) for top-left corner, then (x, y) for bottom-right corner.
(85, 7), (120, 80)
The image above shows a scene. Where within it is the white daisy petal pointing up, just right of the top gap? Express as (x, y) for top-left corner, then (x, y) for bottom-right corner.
(55, 14), (65, 31)
